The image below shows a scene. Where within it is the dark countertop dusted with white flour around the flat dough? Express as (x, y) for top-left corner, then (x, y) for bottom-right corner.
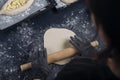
(0, 1), (103, 80)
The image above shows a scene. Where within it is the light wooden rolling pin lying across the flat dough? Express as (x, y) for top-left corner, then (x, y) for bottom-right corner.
(20, 41), (99, 71)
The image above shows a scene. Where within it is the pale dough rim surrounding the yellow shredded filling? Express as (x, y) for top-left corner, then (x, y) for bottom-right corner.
(0, 0), (34, 15)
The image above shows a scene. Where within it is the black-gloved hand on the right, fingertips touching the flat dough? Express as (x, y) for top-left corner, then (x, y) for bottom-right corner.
(70, 36), (97, 58)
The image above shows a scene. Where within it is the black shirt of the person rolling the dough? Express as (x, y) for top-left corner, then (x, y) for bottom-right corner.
(55, 57), (119, 80)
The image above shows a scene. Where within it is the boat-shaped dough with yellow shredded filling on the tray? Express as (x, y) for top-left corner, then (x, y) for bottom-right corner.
(0, 0), (34, 15)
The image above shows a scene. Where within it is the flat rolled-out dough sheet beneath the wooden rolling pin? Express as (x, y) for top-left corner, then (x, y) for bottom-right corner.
(44, 28), (75, 65)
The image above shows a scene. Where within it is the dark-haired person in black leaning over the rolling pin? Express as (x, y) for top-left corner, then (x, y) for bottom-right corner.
(55, 0), (120, 80)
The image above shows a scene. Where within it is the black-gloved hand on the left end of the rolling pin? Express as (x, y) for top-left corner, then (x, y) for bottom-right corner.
(32, 48), (50, 76)
